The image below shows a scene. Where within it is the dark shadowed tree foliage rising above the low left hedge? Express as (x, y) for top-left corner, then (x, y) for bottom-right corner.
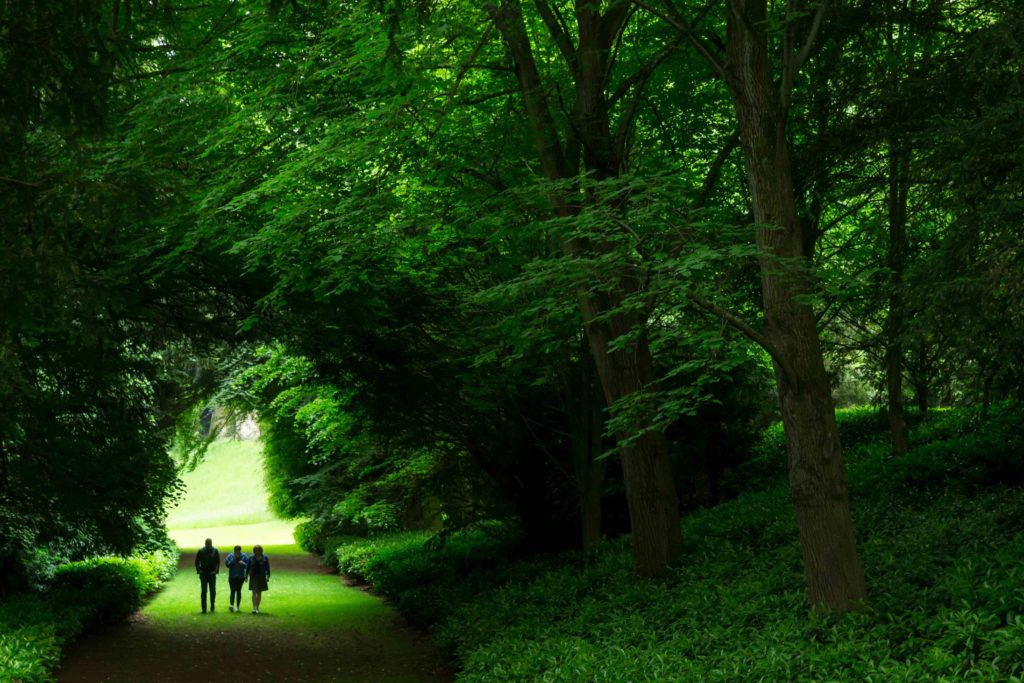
(0, 1), (247, 595)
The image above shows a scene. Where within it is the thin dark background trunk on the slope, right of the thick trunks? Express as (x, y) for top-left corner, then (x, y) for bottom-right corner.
(885, 140), (910, 456)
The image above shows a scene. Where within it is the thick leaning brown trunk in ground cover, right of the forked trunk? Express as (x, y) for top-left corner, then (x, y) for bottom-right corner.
(726, 0), (866, 609)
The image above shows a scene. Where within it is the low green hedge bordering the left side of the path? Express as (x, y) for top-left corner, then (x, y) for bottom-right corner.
(0, 550), (178, 683)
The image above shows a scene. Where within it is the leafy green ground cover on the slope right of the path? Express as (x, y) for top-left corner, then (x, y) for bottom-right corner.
(337, 408), (1024, 682)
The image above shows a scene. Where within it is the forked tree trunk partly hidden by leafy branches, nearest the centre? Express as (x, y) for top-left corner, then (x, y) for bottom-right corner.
(487, 0), (682, 577)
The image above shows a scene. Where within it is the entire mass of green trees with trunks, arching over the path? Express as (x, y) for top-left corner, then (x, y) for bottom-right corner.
(0, 0), (1024, 607)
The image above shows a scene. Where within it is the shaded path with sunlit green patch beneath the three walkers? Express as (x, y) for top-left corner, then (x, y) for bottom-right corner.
(58, 555), (454, 683)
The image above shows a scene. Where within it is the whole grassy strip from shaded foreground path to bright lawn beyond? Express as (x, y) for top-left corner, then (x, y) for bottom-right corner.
(52, 440), (452, 683)
